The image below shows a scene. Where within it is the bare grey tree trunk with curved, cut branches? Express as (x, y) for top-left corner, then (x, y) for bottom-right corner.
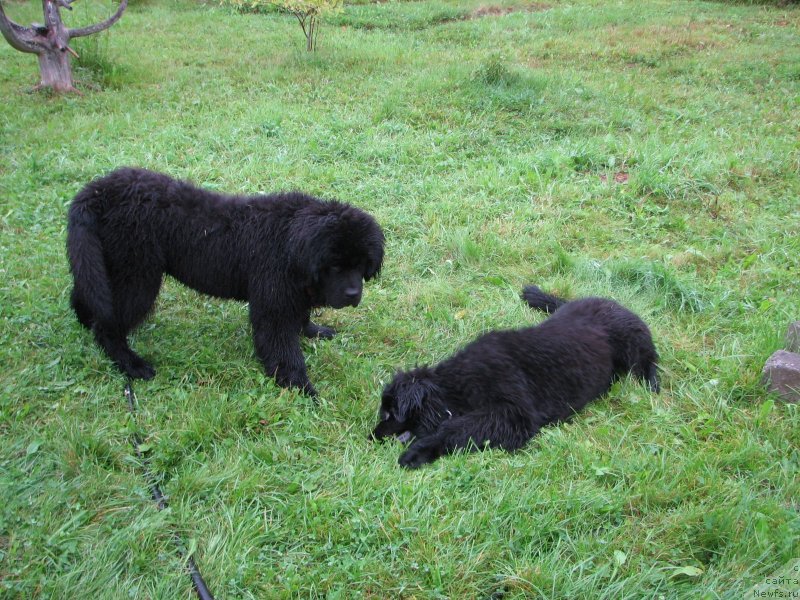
(0, 0), (128, 92)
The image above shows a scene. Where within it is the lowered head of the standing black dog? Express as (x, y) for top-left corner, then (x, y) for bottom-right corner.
(292, 201), (384, 308)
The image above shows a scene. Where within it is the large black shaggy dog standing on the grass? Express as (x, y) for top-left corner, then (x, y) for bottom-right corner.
(67, 168), (384, 395)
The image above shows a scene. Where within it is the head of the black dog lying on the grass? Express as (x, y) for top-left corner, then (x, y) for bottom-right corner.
(372, 368), (452, 441)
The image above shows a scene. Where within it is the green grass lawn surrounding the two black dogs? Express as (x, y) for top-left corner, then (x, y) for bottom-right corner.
(0, 0), (800, 599)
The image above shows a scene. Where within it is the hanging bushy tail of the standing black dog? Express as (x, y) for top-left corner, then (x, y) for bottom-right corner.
(67, 184), (114, 328)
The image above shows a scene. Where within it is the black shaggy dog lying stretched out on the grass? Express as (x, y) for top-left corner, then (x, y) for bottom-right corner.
(372, 286), (659, 468)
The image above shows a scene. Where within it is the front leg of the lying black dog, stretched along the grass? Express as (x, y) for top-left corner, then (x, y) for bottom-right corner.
(398, 411), (538, 469)
